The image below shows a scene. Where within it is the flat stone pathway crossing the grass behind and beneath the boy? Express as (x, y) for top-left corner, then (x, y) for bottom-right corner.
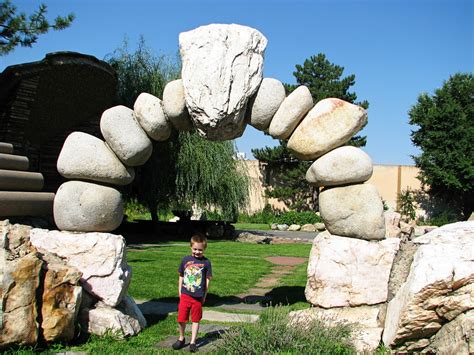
(145, 256), (307, 352)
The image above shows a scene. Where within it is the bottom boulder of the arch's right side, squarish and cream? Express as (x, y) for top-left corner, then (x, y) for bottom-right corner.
(319, 184), (385, 240)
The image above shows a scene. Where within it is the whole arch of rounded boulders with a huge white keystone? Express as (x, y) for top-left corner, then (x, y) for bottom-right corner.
(54, 24), (385, 240)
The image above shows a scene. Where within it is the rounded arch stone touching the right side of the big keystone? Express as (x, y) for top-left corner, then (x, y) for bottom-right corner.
(247, 78), (285, 131)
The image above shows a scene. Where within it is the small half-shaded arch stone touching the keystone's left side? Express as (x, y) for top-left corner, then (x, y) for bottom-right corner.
(163, 79), (194, 131)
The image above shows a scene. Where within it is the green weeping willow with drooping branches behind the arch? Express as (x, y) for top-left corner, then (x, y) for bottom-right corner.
(106, 38), (248, 223)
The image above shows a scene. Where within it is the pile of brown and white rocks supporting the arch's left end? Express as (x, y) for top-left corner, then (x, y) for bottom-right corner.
(0, 220), (146, 349)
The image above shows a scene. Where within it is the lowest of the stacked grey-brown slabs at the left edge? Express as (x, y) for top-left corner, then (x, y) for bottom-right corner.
(0, 191), (54, 217)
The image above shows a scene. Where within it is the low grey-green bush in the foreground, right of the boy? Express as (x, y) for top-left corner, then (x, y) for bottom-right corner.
(217, 307), (355, 354)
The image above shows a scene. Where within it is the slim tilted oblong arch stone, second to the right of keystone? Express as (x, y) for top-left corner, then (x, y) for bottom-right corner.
(268, 85), (313, 139)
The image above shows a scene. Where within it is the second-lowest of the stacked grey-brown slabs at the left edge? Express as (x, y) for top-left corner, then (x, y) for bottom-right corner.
(0, 169), (44, 191)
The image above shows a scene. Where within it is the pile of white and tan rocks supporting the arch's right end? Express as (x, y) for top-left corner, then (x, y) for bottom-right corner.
(291, 221), (474, 354)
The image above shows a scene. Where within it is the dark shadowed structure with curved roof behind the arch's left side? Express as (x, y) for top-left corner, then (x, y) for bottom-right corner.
(0, 52), (117, 192)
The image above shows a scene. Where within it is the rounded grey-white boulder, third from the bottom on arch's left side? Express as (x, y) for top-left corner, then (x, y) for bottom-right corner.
(100, 106), (153, 166)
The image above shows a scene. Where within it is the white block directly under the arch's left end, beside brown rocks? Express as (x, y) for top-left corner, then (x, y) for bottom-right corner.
(30, 228), (131, 307)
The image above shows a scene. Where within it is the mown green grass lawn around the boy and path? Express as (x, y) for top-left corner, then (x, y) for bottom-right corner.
(25, 241), (311, 354)
